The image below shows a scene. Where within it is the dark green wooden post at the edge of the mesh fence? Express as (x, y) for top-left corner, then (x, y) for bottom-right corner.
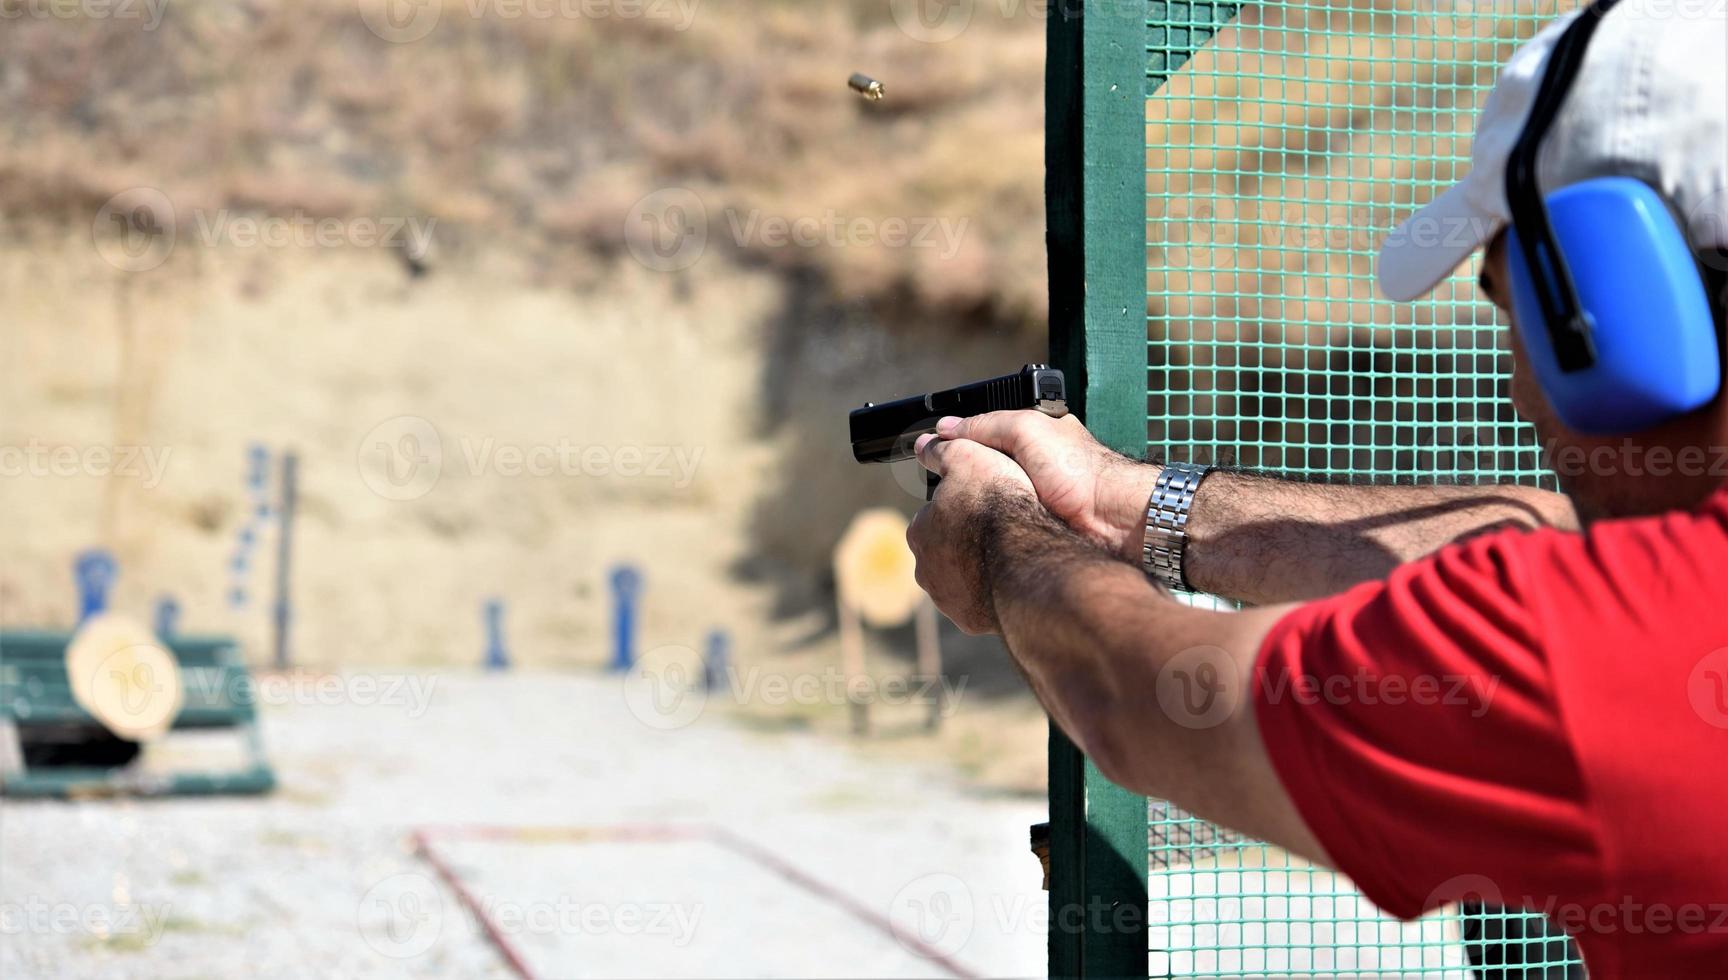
(1044, 0), (1147, 977)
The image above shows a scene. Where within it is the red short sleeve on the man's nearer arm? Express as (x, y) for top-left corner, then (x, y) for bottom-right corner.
(1255, 532), (1602, 918)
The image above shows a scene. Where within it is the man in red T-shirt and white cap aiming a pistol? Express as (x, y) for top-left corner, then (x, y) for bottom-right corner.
(907, 3), (1728, 980)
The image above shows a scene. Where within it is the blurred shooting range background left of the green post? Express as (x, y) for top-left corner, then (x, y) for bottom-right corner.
(0, 0), (1047, 977)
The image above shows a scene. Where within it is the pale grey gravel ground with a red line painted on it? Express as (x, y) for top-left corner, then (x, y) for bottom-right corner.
(0, 674), (1044, 978)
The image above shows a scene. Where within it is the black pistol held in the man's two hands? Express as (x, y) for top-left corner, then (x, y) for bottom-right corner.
(850, 365), (1068, 500)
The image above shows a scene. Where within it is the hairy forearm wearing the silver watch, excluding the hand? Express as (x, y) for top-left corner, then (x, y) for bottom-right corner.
(1111, 465), (1578, 603)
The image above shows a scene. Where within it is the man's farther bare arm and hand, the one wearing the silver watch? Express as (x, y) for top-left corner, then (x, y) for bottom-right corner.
(940, 411), (1578, 603)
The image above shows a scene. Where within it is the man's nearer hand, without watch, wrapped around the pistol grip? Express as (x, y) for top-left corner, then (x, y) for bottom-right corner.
(905, 436), (1033, 636)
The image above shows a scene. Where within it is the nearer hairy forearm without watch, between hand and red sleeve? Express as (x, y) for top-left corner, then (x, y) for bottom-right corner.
(982, 498), (1324, 861)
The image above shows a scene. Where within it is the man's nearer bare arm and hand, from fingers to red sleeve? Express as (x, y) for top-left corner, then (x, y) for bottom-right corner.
(907, 442), (1325, 862)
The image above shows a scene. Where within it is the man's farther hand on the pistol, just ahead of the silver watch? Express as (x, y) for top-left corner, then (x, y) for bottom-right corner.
(937, 411), (1159, 563)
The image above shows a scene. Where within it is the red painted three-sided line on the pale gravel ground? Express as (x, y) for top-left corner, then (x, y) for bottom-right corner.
(415, 824), (978, 980)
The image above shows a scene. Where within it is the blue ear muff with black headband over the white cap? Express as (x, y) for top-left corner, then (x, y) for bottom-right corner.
(1507, 0), (1721, 436)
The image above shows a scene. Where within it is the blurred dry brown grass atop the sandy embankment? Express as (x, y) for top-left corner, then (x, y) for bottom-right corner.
(0, 0), (1045, 325)
